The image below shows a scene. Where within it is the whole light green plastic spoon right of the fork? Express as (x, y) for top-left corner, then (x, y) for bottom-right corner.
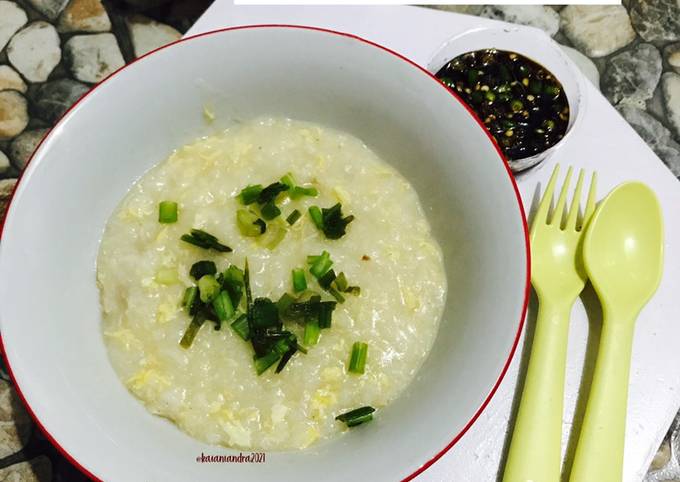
(569, 182), (663, 482)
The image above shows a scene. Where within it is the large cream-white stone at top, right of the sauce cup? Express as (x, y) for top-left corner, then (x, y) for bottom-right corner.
(560, 5), (635, 57)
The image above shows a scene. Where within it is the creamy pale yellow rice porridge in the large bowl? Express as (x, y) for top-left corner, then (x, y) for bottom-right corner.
(97, 118), (446, 450)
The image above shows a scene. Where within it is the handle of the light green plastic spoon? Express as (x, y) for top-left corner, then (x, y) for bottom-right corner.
(569, 316), (635, 482)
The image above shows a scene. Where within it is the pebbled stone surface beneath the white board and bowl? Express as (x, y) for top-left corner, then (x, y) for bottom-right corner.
(0, 0), (680, 482)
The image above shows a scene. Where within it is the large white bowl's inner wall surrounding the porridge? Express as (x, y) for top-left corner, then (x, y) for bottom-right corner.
(0, 27), (528, 482)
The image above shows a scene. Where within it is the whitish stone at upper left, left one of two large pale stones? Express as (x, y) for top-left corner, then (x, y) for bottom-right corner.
(7, 21), (61, 82)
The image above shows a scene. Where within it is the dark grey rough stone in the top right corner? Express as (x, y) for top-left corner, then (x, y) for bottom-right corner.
(630, 0), (680, 42)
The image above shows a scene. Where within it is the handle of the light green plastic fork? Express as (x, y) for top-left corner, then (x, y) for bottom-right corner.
(503, 300), (573, 482)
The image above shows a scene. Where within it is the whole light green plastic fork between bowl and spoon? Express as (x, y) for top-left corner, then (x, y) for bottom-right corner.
(503, 165), (597, 482)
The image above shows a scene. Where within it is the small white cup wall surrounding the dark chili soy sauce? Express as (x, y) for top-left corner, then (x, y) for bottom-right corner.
(427, 26), (586, 172)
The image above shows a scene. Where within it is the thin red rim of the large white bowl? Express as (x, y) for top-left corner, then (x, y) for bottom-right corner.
(0, 23), (531, 482)
